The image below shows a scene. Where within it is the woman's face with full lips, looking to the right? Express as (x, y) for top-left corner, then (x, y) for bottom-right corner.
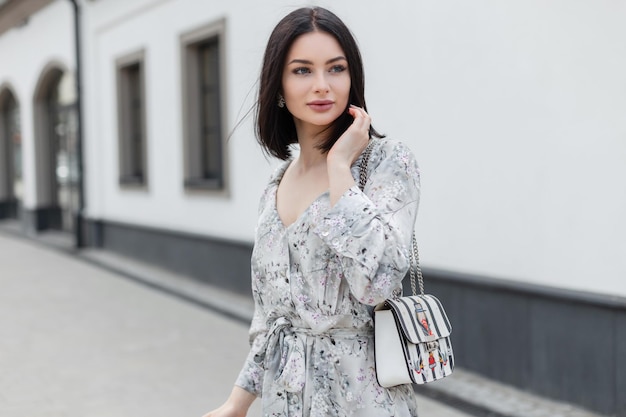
(282, 32), (350, 135)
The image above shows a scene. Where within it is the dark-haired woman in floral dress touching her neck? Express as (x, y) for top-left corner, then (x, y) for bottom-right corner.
(205, 7), (419, 417)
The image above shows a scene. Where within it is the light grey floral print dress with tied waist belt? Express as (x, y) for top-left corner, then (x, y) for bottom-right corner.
(236, 139), (419, 417)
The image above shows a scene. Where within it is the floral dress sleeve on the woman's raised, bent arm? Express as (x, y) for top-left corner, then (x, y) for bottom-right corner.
(314, 140), (420, 305)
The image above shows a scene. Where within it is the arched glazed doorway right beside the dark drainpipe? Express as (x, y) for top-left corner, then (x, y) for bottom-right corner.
(35, 66), (78, 231)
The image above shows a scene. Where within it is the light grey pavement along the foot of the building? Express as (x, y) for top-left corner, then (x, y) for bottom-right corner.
(0, 230), (469, 417)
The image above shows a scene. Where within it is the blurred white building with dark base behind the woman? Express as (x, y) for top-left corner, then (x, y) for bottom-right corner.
(0, 0), (626, 416)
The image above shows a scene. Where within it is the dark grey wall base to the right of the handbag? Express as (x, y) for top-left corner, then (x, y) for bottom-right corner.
(414, 268), (626, 416)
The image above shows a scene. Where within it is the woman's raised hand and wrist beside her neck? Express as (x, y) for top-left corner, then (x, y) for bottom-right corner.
(326, 106), (371, 206)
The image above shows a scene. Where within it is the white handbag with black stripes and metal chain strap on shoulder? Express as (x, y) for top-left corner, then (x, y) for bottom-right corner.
(359, 141), (454, 388)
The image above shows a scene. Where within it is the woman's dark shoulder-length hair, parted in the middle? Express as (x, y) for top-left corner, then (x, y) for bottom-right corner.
(255, 7), (384, 160)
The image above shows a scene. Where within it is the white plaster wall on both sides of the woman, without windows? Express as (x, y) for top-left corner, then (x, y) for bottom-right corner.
(0, 0), (626, 296)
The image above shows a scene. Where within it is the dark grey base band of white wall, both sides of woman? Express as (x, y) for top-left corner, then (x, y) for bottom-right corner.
(84, 219), (626, 416)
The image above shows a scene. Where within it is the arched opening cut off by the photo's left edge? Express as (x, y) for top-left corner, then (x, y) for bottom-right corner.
(0, 87), (23, 219)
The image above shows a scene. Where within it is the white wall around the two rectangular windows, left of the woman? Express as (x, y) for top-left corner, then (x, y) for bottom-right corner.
(81, 1), (290, 241)
